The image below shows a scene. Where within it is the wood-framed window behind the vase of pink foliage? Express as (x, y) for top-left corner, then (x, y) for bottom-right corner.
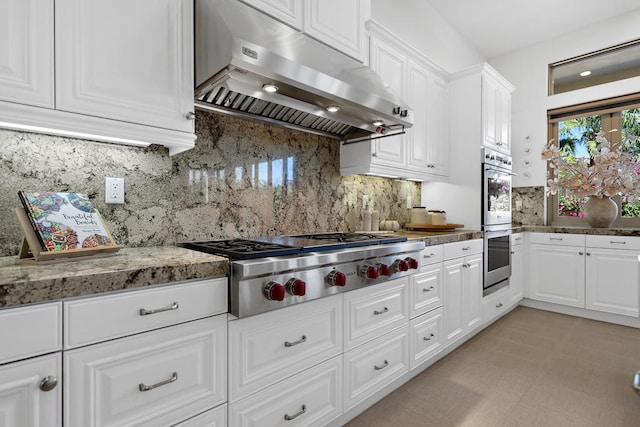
(547, 93), (640, 227)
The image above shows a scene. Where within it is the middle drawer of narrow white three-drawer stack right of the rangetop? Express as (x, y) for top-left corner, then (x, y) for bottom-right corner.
(409, 263), (444, 319)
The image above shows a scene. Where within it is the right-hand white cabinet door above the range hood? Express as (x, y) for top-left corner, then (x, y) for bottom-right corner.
(304, 0), (371, 62)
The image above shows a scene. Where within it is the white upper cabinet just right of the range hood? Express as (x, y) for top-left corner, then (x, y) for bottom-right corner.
(340, 23), (449, 181)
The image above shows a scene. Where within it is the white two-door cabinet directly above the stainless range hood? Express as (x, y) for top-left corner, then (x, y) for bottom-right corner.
(240, 0), (371, 62)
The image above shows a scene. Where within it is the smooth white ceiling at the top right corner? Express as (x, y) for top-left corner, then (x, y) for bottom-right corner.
(426, 0), (640, 58)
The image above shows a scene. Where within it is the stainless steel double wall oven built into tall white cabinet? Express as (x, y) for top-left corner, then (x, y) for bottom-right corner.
(482, 148), (513, 295)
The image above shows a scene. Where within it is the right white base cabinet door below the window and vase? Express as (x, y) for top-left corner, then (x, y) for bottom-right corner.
(586, 248), (640, 317)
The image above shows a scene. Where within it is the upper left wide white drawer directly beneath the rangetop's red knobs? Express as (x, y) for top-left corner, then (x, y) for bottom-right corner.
(229, 295), (343, 402)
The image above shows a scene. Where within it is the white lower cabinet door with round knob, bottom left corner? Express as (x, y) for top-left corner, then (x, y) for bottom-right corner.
(0, 353), (62, 427)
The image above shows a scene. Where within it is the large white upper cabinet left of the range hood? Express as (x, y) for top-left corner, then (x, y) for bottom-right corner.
(0, 0), (195, 154)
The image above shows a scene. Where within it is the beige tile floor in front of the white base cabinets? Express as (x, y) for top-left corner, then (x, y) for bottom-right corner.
(347, 307), (640, 427)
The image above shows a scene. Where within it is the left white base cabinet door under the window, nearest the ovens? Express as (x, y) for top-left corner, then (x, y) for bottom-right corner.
(529, 243), (585, 308)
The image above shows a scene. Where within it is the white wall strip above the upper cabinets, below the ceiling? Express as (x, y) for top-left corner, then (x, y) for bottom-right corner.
(371, 0), (485, 73)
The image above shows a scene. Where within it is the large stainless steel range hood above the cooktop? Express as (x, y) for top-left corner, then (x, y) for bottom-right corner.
(195, 0), (413, 141)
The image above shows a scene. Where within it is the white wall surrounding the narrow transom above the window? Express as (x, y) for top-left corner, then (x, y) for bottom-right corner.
(488, 9), (640, 187)
